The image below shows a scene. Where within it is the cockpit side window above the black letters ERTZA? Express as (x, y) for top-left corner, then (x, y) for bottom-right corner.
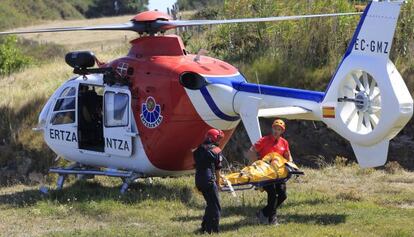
(49, 86), (77, 126)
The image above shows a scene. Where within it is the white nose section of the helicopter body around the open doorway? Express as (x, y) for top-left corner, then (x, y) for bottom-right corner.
(39, 75), (184, 176)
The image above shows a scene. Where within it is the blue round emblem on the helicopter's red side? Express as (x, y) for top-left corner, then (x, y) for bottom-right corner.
(141, 96), (163, 128)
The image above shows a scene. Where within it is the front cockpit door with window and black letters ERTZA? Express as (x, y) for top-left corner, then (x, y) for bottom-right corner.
(47, 86), (78, 149)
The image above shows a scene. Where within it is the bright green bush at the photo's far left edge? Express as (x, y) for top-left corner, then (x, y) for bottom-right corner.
(0, 36), (32, 75)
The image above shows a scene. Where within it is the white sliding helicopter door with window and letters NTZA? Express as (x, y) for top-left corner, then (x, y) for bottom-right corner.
(104, 87), (132, 157)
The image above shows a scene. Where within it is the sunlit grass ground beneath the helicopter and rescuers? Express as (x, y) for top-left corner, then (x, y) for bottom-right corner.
(0, 165), (414, 236)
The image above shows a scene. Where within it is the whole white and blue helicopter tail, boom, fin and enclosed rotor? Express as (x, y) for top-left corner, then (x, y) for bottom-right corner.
(234, 1), (413, 167)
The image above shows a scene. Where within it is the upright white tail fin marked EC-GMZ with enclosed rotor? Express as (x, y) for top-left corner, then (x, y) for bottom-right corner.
(321, 0), (413, 167)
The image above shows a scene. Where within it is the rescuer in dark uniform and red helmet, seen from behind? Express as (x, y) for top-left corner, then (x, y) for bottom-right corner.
(193, 129), (224, 234)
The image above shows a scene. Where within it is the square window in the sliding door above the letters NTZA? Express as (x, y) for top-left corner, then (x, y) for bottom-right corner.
(105, 92), (129, 127)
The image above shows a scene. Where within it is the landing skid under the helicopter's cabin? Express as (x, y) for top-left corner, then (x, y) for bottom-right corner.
(41, 163), (144, 194)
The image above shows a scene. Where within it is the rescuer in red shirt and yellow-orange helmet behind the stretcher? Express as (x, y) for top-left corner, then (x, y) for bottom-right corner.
(249, 119), (293, 225)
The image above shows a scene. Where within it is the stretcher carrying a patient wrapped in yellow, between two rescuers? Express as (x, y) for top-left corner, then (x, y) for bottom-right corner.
(220, 153), (304, 191)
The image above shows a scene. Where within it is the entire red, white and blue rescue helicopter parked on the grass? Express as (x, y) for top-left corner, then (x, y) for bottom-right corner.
(0, 0), (413, 191)
